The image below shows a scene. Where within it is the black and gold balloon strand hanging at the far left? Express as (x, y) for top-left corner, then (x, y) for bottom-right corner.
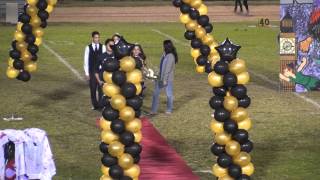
(7, 0), (57, 81)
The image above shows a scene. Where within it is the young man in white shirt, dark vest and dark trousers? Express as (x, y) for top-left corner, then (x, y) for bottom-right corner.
(84, 31), (106, 110)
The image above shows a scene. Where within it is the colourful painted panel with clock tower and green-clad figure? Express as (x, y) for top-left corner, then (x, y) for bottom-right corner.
(279, 0), (320, 92)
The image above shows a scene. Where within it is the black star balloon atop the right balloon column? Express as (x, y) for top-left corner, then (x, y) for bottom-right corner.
(216, 38), (241, 62)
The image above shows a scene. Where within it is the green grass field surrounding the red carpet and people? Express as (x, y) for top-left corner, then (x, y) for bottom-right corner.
(0, 23), (320, 180)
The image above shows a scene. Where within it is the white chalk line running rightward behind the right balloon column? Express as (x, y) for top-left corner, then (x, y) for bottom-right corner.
(152, 29), (320, 109)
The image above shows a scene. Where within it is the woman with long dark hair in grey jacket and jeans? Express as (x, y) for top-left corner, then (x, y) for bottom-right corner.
(150, 40), (178, 115)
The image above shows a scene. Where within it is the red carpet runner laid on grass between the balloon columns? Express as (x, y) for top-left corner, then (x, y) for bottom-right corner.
(139, 118), (199, 180)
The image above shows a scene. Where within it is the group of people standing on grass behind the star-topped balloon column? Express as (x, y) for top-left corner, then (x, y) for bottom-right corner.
(84, 31), (178, 115)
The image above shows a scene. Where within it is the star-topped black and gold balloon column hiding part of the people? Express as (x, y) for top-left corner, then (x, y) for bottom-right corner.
(100, 39), (143, 180)
